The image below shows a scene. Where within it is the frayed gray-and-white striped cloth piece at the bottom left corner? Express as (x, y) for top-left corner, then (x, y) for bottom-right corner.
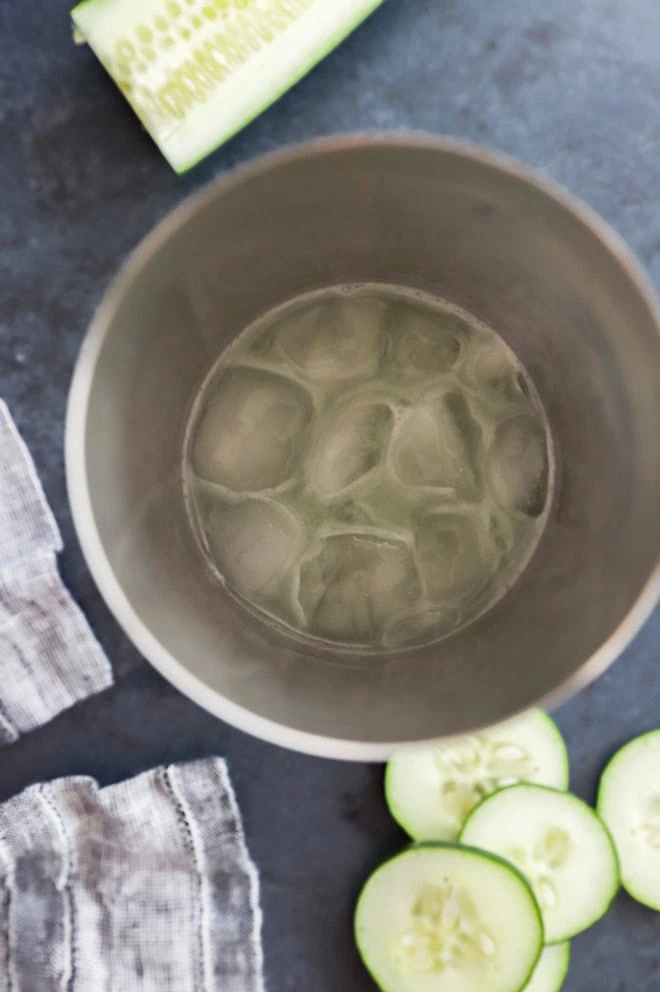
(0, 758), (263, 992)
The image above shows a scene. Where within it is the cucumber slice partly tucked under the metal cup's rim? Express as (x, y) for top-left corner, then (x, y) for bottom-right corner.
(385, 710), (569, 841)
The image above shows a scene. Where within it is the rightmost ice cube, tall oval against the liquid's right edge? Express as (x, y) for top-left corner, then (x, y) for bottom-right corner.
(486, 416), (548, 517)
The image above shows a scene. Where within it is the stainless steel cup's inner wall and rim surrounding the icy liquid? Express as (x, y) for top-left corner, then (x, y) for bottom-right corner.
(67, 130), (660, 758)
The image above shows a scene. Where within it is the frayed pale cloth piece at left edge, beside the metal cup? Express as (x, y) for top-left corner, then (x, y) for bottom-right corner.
(0, 402), (112, 743)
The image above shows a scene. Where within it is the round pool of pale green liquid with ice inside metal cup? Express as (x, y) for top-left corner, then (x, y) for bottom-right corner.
(184, 285), (553, 651)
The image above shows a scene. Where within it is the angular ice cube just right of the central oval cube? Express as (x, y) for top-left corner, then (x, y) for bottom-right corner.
(391, 392), (482, 500)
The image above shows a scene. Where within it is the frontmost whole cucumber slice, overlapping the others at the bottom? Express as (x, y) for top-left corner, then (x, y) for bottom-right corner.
(355, 844), (543, 992)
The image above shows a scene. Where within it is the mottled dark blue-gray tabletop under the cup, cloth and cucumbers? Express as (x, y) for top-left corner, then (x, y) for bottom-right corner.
(0, 0), (660, 992)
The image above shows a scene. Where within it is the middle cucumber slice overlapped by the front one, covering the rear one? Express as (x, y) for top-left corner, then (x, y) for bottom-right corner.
(460, 785), (619, 944)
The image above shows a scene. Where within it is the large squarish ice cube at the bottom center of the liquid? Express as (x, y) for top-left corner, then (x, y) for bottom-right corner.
(300, 532), (420, 645)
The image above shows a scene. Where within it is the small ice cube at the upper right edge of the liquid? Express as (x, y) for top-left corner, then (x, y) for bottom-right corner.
(462, 329), (529, 403)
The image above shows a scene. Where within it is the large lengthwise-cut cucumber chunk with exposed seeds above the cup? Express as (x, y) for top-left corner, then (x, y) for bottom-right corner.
(71, 0), (382, 172)
